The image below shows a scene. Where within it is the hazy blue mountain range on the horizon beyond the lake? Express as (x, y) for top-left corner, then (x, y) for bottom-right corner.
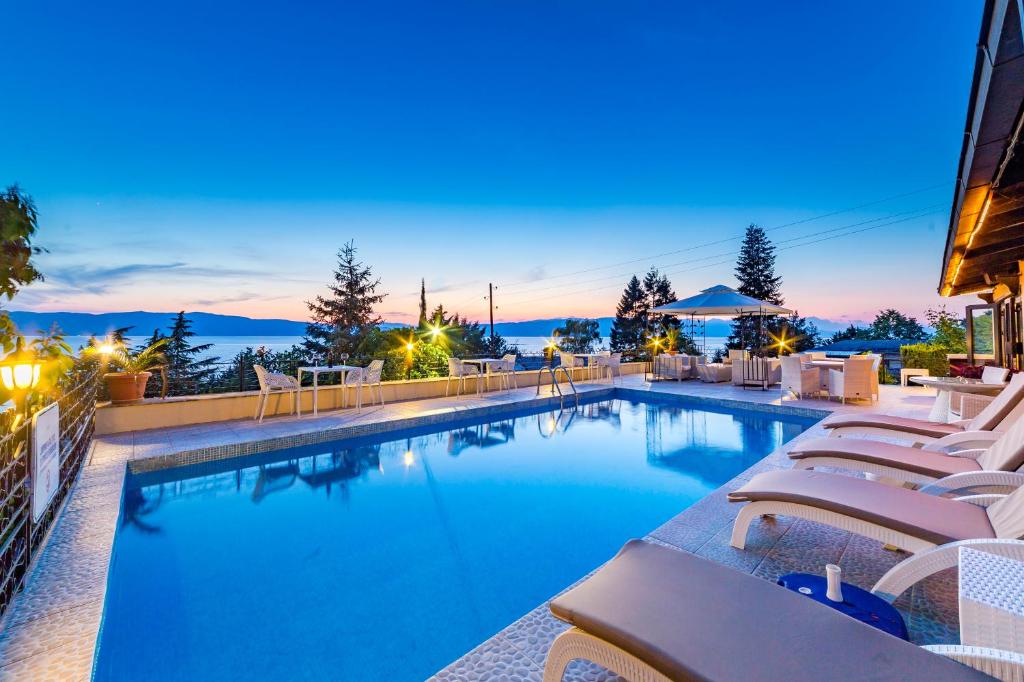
(10, 310), (867, 338)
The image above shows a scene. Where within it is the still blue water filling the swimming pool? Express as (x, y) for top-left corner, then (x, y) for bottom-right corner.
(96, 399), (813, 680)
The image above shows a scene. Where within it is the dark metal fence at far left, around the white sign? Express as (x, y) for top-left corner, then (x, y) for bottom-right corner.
(0, 369), (99, 615)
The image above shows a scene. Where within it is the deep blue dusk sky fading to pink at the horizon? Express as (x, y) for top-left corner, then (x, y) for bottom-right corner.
(0, 0), (983, 322)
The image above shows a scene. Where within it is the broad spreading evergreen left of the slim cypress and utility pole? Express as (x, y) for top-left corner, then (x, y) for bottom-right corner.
(302, 242), (387, 355)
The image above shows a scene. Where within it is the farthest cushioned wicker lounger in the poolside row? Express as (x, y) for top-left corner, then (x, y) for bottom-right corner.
(821, 373), (1024, 443)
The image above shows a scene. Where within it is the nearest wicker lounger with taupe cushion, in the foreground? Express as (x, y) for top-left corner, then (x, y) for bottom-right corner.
(544, 540), (999, 682)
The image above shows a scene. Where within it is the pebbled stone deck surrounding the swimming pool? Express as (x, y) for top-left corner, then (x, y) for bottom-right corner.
(0, 376), (957, 680)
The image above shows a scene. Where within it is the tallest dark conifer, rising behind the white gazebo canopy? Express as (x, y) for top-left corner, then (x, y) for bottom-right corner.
(726, 223), (782, 348)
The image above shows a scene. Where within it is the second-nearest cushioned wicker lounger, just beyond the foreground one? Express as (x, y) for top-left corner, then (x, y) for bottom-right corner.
(728, 469), (1024, 553)
